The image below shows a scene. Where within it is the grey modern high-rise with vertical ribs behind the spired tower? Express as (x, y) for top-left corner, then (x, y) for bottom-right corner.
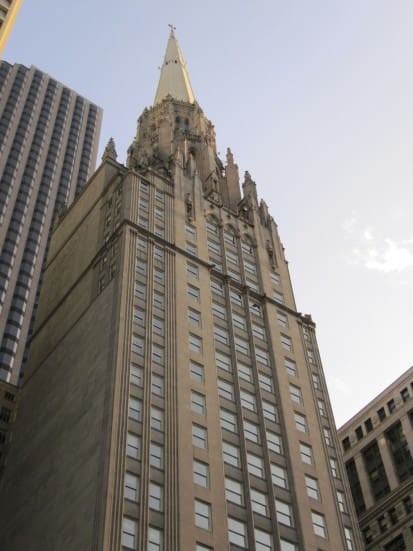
(0, 61), (102, 384)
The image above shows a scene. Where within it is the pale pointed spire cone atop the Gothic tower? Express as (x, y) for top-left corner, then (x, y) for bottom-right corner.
(154, 25), (195, 105)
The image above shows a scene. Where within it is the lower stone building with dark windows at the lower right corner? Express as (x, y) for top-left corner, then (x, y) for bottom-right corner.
(339, 367), (413, 551)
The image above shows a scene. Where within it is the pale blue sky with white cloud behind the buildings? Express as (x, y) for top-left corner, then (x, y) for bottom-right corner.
(4, 0), (413, 425)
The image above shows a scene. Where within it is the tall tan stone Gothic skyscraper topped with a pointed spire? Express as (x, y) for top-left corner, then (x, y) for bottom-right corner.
(0, 31), (362, 551)
